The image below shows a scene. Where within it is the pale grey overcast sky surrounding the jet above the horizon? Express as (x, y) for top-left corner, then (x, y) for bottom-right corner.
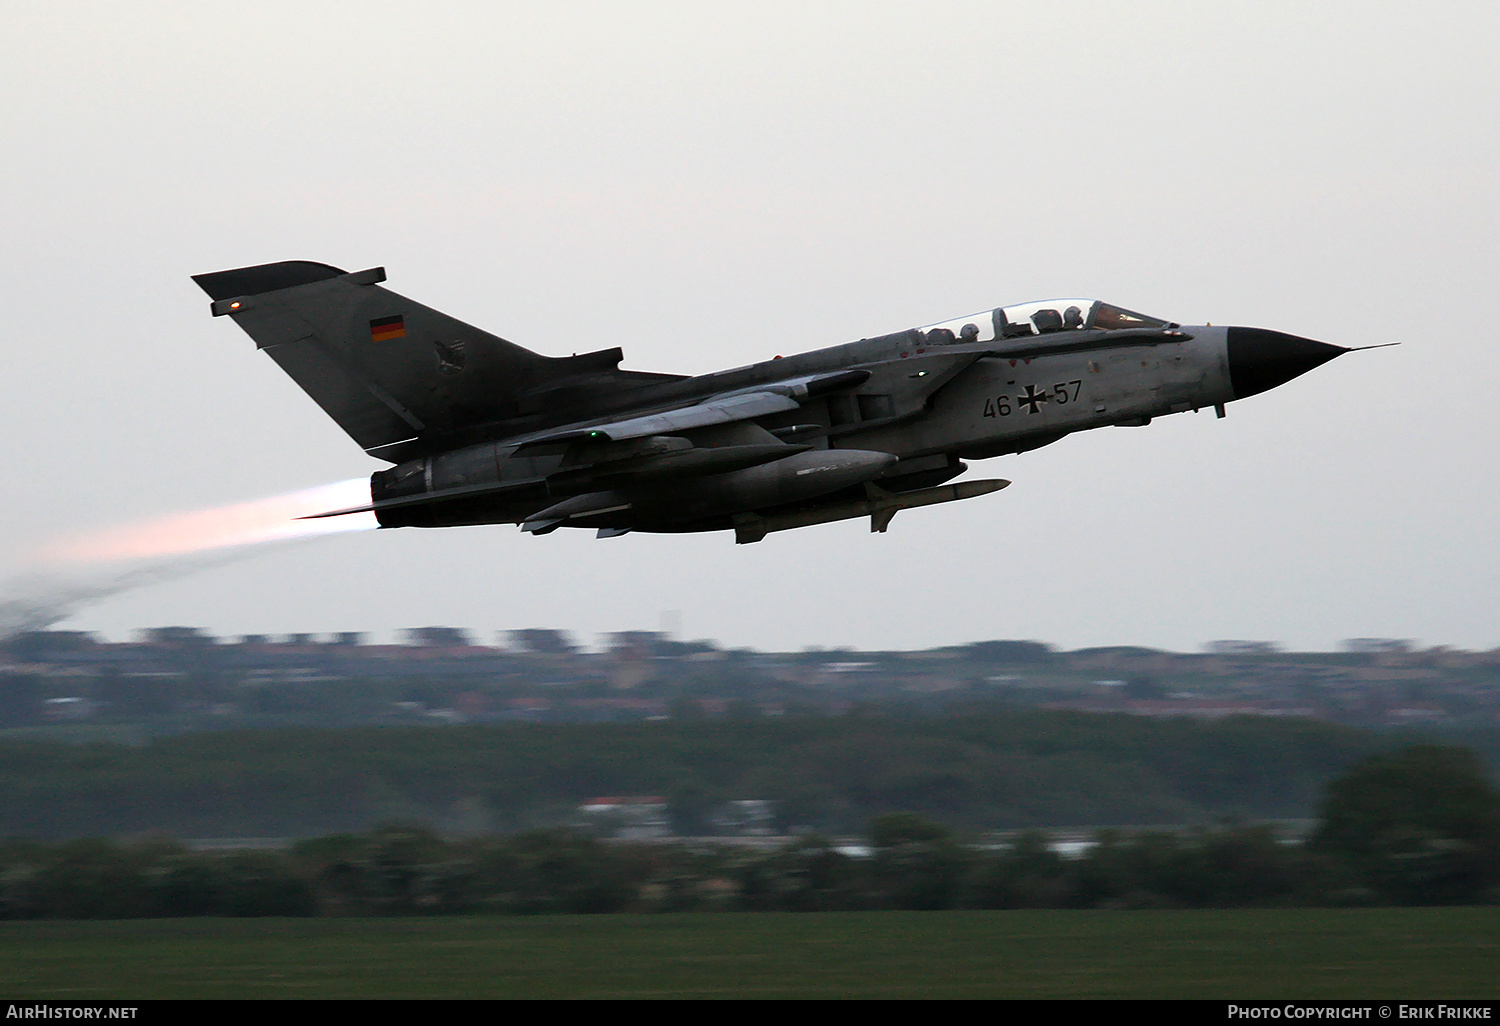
(0, 0), (1500, 650)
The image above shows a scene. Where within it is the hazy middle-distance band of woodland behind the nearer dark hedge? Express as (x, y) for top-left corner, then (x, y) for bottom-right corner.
(0, 707), (1452, 839)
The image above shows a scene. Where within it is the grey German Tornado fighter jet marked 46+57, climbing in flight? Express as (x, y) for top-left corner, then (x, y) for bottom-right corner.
(194, 261), (1349, 543)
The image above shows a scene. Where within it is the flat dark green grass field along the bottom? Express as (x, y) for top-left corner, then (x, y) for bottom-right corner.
(0, 908), (1500, 999)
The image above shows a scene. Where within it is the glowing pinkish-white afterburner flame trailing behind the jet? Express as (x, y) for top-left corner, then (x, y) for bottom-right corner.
(35, 477), (378, 563)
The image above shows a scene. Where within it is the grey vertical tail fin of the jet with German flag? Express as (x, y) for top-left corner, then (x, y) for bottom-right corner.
(194, 260), (621, 462)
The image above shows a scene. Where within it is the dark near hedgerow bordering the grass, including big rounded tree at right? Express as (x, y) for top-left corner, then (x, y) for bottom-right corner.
(0, 747), (1500, 918)
